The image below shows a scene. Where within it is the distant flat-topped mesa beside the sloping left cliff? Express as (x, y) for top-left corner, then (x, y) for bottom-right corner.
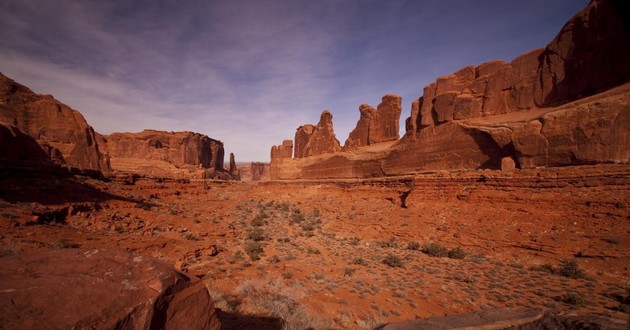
(103, 130), (230, 171)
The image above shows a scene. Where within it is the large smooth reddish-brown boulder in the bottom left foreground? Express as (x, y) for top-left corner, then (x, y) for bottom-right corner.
(0, 249), (220, 329)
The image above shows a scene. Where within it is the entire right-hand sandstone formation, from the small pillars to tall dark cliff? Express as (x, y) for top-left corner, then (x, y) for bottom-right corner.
(270, 0), (630, 179)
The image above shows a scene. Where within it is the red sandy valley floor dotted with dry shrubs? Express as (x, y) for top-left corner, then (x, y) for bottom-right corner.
(0, 165), (630, 328)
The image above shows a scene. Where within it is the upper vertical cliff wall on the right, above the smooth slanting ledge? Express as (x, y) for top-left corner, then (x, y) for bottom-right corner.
(407, 0), (630, 136)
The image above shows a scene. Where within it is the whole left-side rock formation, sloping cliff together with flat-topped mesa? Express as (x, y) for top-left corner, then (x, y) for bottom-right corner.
(0, 74), (238, 179)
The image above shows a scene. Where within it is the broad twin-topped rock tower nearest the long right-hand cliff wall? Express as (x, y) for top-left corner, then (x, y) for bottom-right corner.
(343, 95), (402, 150)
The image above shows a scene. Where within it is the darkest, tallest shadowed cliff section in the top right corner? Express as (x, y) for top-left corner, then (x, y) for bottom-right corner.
(536, 0), (630, 105)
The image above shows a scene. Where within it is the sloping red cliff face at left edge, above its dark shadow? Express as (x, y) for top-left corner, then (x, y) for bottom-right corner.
(0, 74), (110, 173)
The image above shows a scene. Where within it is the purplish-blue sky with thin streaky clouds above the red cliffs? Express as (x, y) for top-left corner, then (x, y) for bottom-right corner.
(0, 0), (588, 161)
